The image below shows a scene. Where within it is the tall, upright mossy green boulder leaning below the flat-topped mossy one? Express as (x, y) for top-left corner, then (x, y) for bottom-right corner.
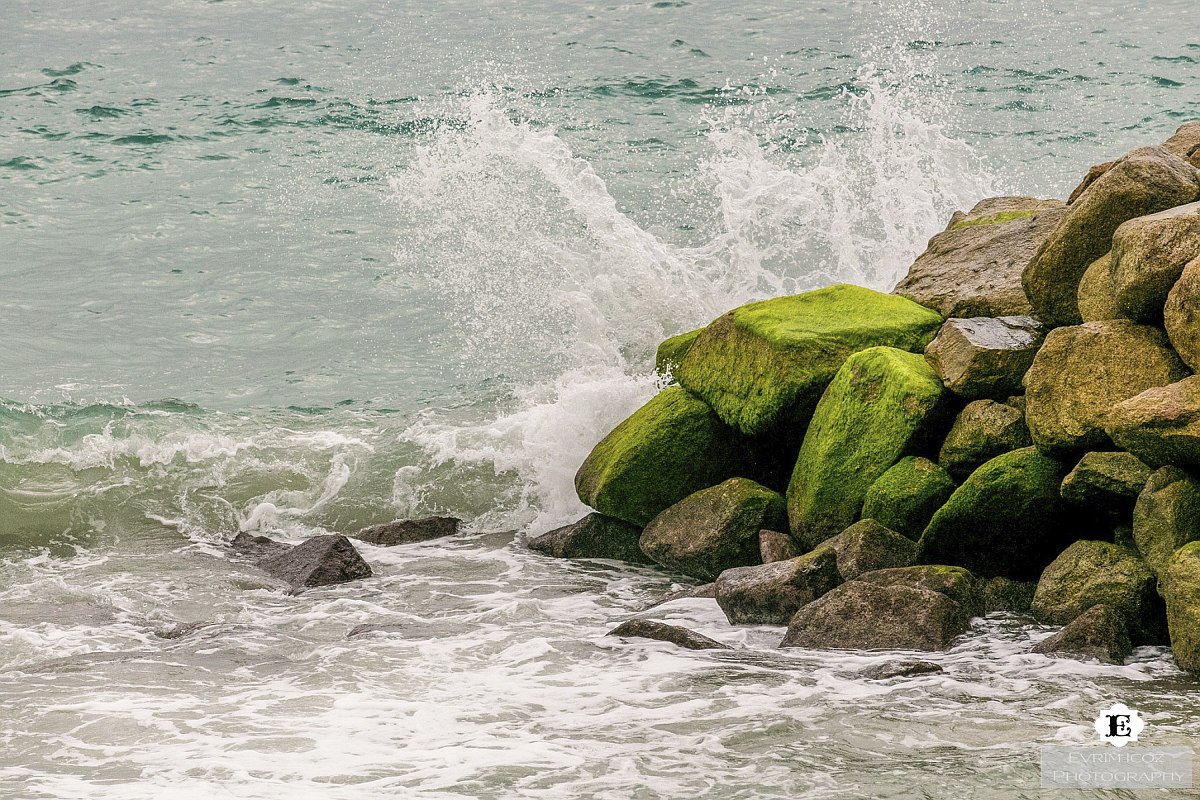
(787, 348), (943, 549)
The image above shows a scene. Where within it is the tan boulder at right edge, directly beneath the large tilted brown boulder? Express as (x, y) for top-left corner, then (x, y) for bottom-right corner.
(1110, 203), (1200, 324)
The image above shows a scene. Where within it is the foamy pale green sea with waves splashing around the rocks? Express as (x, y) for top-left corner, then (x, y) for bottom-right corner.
(0, 0), (1200, 800)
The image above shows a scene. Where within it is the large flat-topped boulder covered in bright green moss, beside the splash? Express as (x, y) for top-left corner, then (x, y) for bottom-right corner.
(676, 284), (942, 435)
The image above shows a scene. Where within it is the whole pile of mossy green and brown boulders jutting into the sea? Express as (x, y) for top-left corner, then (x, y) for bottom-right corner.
(530, 122), (1200, 673)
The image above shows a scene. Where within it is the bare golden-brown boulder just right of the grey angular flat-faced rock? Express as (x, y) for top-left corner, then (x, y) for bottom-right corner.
(1025, 319), (1188, 456)
